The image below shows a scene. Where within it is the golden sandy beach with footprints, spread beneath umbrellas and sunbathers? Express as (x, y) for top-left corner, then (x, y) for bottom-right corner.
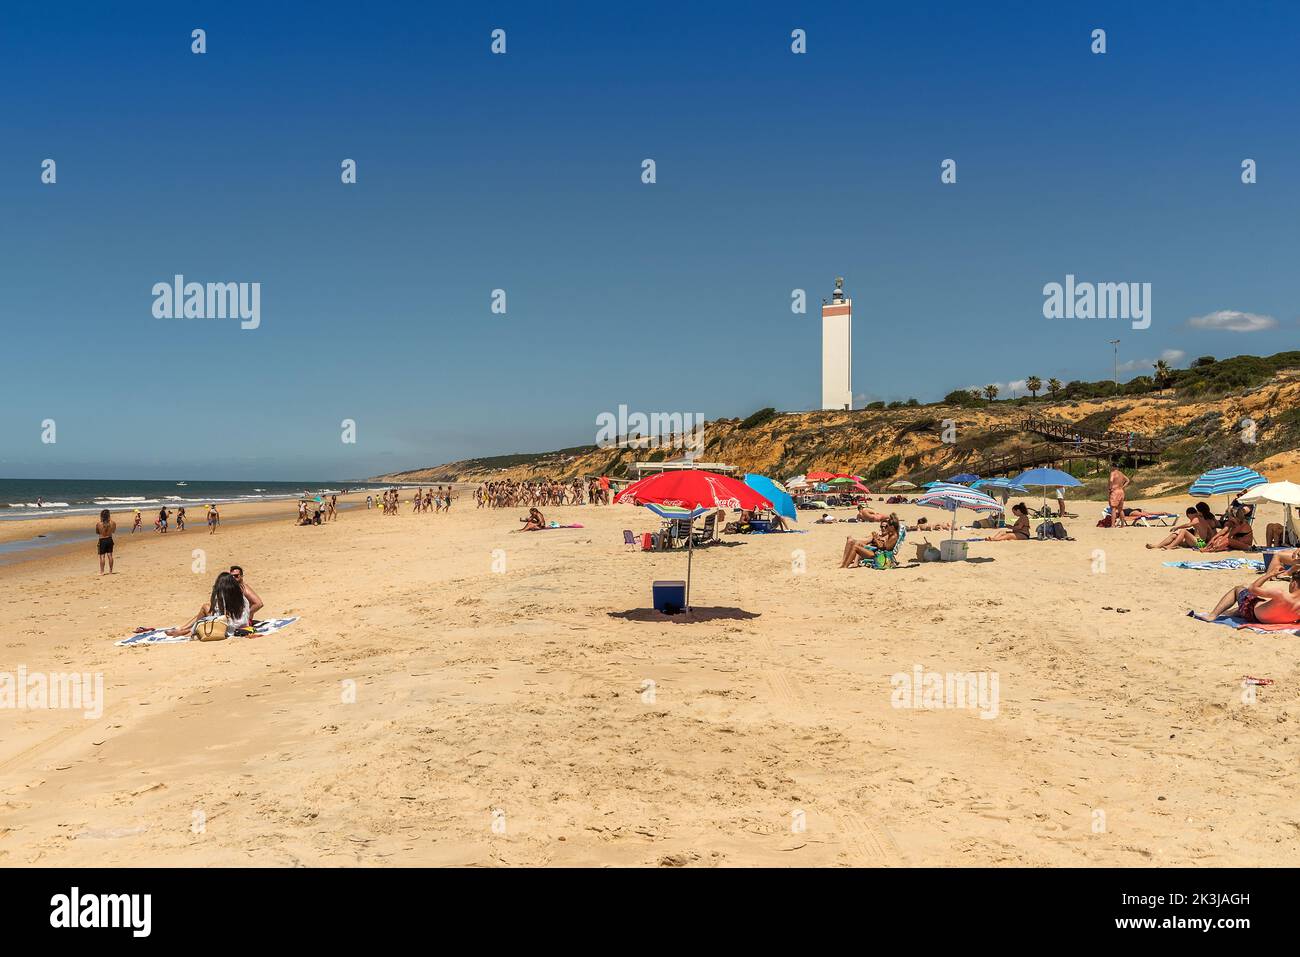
(0, 498), (1300, 867)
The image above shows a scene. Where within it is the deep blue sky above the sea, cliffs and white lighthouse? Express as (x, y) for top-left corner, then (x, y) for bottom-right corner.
(0, 3), (1300, 479)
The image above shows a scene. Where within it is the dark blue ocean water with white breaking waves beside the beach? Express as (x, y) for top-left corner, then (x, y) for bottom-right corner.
(0, 479), (389, 524)
